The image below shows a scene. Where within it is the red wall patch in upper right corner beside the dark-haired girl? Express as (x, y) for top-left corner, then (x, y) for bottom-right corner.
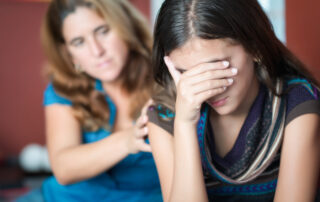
(286, 0), (320, 81)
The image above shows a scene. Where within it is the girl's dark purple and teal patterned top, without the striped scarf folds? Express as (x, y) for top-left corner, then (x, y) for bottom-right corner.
(148, 78), (320, 202)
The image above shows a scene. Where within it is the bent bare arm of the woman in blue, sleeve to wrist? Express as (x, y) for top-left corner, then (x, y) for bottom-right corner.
(45, 104), (147, 184)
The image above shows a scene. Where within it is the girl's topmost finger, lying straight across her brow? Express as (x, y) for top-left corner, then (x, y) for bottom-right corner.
(183, 60), (230, 77)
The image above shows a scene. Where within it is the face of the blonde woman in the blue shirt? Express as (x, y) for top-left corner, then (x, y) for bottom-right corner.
(62, 7), (128, 83)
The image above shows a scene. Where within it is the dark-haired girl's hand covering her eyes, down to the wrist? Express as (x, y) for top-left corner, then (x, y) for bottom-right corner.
(164, 56), (237, 124)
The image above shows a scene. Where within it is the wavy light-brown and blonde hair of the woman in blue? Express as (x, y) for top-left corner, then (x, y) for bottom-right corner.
(41, 0), (153, 131)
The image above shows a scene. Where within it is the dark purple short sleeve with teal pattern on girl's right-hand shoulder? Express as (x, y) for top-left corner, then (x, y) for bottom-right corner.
(284, 77), (320, 125)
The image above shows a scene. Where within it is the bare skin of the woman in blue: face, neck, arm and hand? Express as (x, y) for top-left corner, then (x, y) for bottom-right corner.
(45, 7), (151, 185)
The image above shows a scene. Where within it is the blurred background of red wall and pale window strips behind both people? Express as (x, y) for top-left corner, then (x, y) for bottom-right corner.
(0, 0), (320, 200)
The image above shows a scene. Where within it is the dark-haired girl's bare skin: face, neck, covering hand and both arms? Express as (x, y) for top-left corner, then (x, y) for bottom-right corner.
(148, 38), (320, 201)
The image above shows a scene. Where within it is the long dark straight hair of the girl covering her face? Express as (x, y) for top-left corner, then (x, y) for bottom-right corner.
(152, 0), (317, 104)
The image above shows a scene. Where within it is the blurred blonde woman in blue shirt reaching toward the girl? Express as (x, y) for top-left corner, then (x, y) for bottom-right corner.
(17, 0), (162, 202)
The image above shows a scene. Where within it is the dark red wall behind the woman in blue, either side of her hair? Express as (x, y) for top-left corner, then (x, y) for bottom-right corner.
(0, 0), (150, 155)
